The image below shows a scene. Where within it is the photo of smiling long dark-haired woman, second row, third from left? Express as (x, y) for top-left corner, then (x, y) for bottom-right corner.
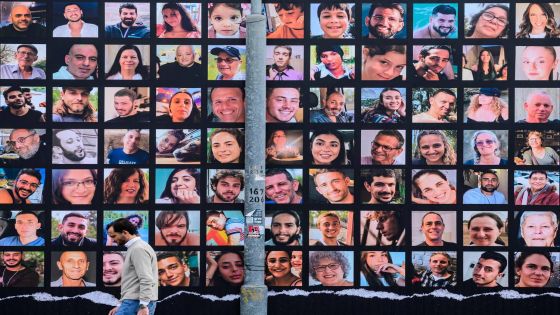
(105, 44), (150, 80)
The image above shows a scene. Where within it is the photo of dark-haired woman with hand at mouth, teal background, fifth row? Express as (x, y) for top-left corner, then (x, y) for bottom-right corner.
(156, 168), (200, 204)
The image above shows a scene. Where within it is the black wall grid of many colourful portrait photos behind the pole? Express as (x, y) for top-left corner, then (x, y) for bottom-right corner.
(0, 0), (560, 292)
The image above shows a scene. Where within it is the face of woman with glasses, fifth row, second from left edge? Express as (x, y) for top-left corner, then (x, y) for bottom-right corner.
(61, 169), (95, 205)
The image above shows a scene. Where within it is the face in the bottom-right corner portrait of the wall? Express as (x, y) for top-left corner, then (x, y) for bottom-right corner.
(515, 254), (552, 288)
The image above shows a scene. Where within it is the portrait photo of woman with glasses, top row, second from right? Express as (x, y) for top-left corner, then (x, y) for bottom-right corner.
(465, 3), (509, 38)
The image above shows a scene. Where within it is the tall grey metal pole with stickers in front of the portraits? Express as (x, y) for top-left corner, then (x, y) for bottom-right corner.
(240, 0), (268, 315)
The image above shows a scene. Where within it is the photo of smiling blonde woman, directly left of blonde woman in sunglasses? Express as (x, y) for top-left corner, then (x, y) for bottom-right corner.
(412, 130), (457, 165)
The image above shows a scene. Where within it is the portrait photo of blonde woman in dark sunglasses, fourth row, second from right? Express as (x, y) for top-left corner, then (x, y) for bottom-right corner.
(464, 130), (507, 166)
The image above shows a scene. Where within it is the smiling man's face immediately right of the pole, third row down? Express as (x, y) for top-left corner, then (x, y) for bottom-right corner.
(266, 88), (300, 122)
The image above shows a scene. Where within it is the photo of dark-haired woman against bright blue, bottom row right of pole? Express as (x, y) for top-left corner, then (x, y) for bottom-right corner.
(360, 251), (406, 288)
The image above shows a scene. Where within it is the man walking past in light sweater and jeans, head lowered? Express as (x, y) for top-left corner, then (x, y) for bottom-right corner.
(107, 218), (158, 315)
